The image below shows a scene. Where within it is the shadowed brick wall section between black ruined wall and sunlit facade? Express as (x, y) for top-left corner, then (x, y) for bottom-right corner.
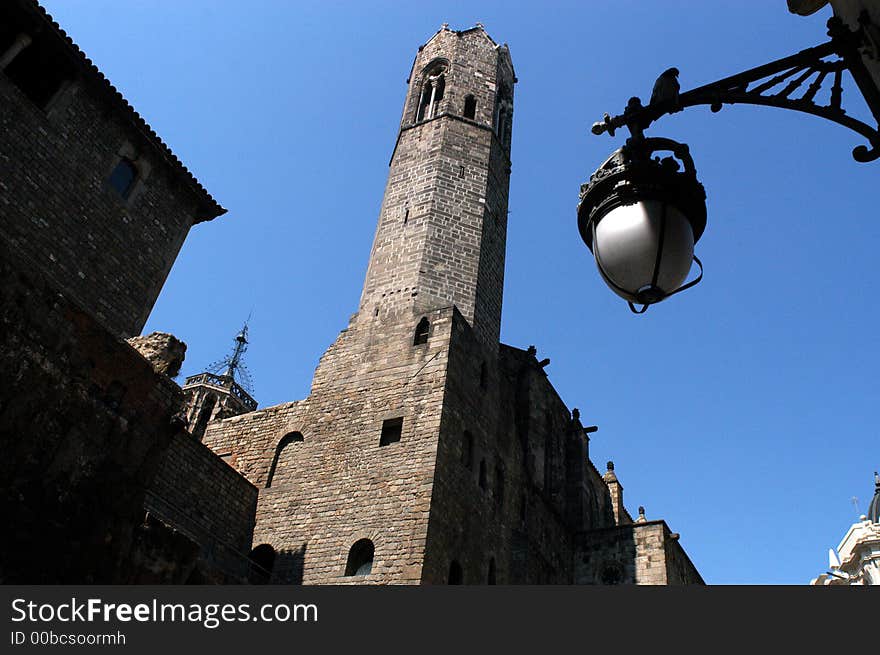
(145, 432), (257, 582)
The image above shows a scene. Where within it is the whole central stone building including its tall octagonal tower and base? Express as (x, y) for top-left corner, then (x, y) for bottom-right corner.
(204, 26), (702, 584)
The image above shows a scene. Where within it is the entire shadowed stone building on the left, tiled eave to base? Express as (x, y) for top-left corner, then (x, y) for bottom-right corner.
(0, 0), (257, 584)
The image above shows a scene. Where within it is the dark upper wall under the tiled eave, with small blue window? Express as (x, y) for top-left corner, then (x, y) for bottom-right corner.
(0, 0), (215, 336)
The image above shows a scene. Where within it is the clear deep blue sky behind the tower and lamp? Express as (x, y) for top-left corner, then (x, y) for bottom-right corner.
(43, 0), (880, 584)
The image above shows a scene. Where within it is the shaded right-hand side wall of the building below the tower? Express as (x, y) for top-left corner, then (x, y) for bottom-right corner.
(422, 314), (610, 584)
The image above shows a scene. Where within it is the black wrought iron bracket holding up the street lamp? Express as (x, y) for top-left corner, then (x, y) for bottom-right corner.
(592, 12), (880, 162)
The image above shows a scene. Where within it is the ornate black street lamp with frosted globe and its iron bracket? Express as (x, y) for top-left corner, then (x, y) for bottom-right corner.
(578, 11), (880, 314)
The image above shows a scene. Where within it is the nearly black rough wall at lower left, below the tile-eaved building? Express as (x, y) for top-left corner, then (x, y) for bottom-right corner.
(0, 242), (183, 584)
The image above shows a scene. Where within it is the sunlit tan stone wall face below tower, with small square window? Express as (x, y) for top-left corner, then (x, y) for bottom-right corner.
(204, 308), (453, 584)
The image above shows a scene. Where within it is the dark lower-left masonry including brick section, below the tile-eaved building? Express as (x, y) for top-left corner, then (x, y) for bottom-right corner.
(0, 241), (257, 584)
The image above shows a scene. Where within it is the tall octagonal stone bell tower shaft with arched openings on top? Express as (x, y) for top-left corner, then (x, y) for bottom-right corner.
(360, 24), (516, 348)
